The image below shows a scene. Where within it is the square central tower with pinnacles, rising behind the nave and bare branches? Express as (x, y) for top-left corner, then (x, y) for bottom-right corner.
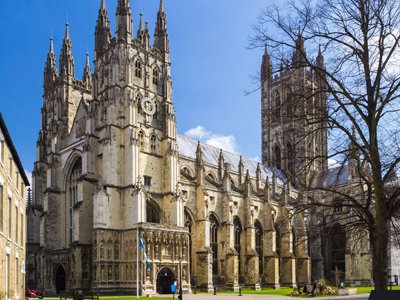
(261, 35), (328, 185)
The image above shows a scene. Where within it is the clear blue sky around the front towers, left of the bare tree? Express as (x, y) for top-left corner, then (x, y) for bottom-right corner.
(0, 0), (267, 180)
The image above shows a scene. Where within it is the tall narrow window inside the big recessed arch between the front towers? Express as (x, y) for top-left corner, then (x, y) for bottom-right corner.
(68, 158), (82, 243)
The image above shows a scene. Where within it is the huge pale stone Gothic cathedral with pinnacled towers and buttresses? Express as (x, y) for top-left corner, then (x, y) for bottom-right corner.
(26, 0), (390, 295)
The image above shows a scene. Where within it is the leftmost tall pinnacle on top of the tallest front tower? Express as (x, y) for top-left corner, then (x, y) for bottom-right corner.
(95, 0), (111, 59)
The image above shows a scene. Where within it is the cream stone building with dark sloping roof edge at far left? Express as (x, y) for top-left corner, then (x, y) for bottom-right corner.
(0, 114), (29, 299)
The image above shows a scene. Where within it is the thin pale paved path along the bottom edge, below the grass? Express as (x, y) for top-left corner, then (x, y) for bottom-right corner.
(159, 294), (369, 300)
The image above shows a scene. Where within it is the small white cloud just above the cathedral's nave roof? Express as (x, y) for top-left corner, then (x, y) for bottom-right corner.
(185, 125), (237, 153)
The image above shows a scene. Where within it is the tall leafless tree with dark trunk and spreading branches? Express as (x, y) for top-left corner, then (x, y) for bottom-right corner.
(250, 0), (400, 290)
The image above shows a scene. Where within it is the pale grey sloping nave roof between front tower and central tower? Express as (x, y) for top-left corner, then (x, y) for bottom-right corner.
(177, 135), (286, 185)
